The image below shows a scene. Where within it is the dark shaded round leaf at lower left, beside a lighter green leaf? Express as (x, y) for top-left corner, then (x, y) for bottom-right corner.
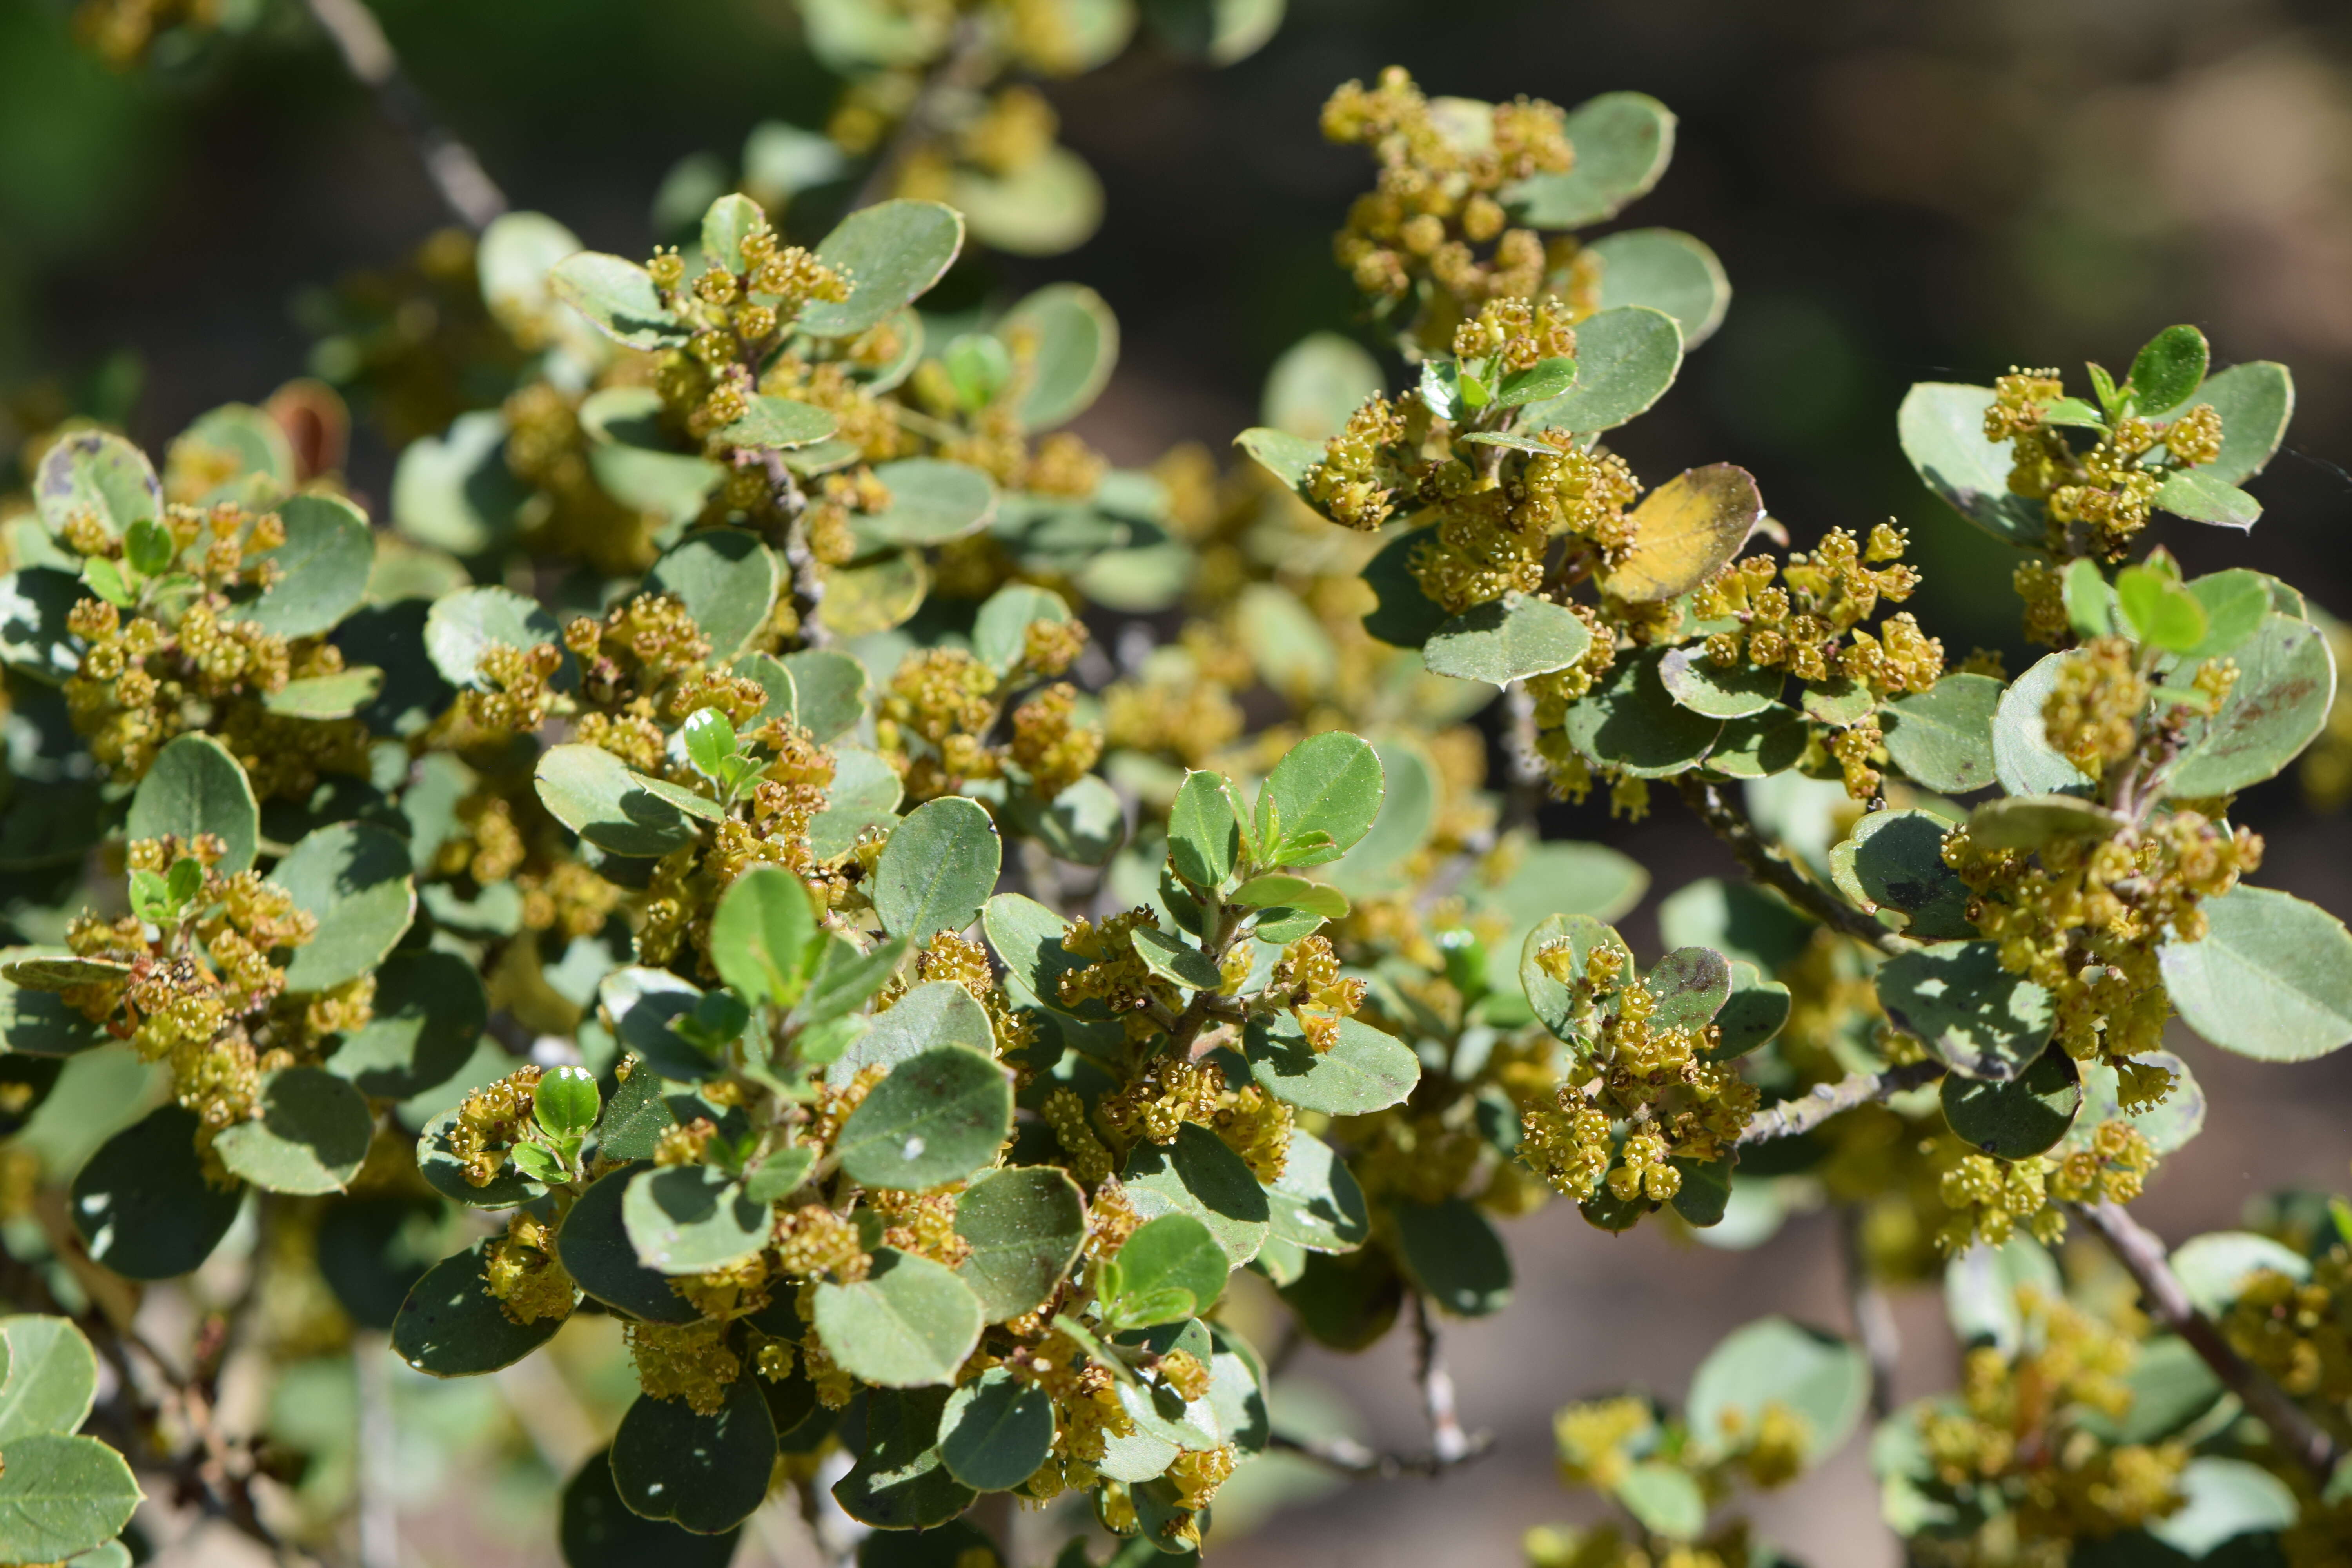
(73, 1105), (245, 1279)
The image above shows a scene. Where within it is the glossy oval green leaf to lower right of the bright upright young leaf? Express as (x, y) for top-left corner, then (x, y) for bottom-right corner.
(835, 1046), (1014, 1189)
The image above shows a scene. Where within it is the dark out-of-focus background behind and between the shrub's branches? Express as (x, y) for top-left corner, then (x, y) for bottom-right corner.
(0, 0), (2352, 1568)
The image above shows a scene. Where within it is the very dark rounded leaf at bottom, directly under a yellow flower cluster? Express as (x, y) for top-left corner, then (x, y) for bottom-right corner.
(612, 1375), (776, 1535)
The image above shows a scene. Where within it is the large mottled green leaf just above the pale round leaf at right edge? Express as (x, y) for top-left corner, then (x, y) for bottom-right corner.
(2164, 613), (2336, 799)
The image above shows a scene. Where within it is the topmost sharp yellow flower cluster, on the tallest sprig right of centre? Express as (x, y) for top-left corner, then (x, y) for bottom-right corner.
(1322, 66), (1576, 313)
